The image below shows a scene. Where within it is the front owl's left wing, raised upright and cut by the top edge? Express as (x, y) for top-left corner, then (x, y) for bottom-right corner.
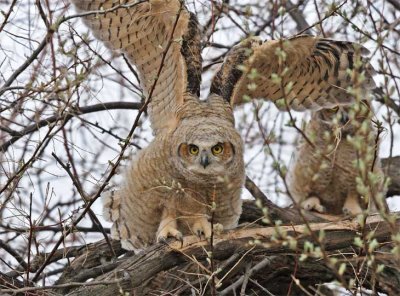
(72, 0), (201, 133)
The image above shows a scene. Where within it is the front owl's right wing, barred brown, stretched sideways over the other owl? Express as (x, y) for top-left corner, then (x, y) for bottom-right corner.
(210, 36), (375, 111)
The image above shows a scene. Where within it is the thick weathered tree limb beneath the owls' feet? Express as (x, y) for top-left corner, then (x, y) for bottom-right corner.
(41, 215), (400, 296)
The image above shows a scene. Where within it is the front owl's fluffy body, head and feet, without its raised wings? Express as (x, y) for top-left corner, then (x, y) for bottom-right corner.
(104, 96), (244, 249)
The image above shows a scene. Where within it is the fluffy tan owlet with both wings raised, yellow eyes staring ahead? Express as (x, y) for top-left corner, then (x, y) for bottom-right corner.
(72, 0), (376, 250)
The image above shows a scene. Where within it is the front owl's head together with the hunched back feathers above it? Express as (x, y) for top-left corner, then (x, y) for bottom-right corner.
(170, 107), (244, 183)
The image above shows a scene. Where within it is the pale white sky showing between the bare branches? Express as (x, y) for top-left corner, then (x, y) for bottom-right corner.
(0, 0), (400, 282)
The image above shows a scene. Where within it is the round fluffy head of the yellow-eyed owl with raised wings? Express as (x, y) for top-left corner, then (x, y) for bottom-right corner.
(174, 117), (244, 181)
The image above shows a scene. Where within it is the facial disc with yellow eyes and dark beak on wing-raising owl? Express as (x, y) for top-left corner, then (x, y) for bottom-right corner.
(178, 139), (236, 176)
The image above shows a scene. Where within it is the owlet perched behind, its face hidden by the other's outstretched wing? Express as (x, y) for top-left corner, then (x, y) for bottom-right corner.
(286, 102), (383, 215)
